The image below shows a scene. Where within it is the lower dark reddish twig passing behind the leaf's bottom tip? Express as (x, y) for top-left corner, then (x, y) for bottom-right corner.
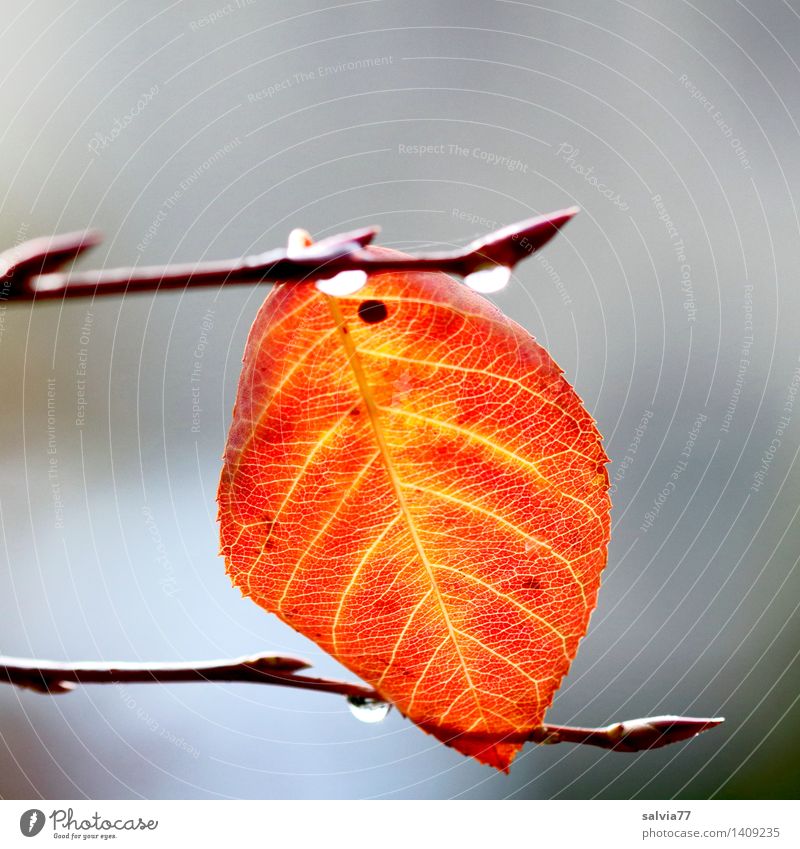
(0, 654), (724, 752)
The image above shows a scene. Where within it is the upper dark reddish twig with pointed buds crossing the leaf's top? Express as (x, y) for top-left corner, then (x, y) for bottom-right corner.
(0, 207), (578, 301)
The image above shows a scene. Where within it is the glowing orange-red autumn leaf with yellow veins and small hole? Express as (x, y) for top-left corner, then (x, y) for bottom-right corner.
(219, 243), (610, 769)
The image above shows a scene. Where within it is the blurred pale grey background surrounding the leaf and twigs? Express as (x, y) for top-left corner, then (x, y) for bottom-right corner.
(0, 0), (800, 798)
